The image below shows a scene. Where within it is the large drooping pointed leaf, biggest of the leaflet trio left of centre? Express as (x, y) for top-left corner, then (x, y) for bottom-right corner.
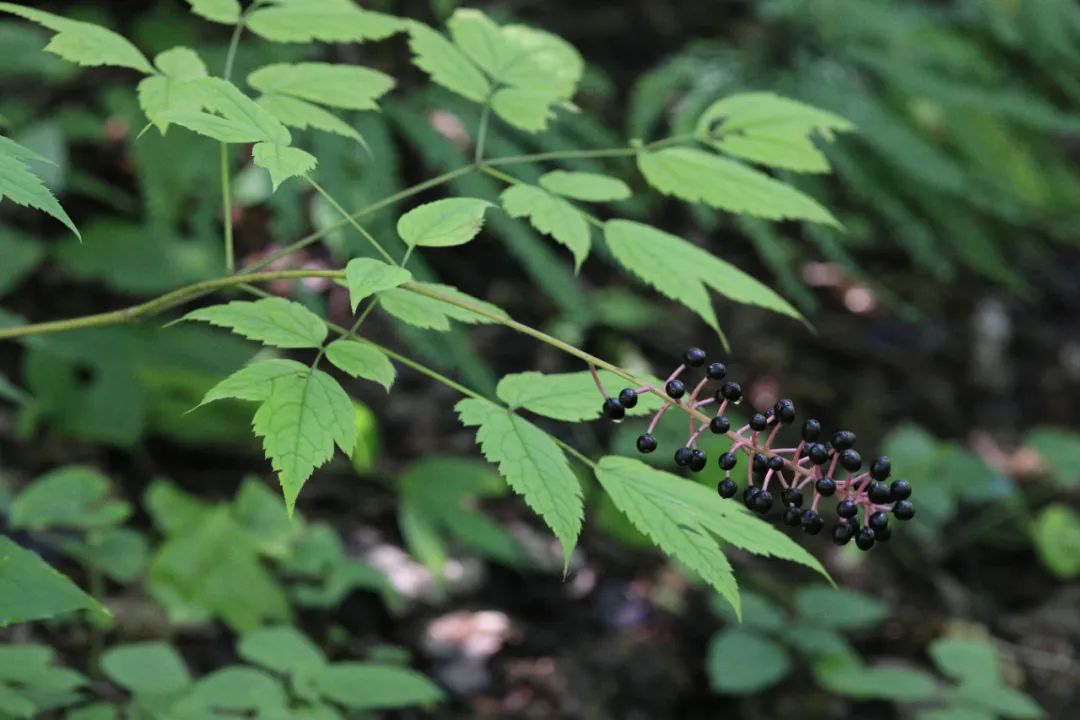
(252, 370), (356, 514)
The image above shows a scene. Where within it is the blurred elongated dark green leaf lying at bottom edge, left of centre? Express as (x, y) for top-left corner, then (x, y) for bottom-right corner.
(312, 663), (445, 710)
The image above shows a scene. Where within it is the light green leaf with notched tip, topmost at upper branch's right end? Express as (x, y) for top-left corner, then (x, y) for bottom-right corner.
(697, 93), (854, 173)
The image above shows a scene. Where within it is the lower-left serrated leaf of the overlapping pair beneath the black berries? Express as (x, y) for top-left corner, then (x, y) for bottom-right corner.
(596, 456), (742, 617)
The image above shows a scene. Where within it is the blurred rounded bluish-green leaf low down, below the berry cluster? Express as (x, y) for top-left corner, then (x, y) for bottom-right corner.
(705, 627), (792, 695)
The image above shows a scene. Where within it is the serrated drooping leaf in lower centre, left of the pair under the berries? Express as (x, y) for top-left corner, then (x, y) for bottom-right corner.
(455, 398), (583, 562)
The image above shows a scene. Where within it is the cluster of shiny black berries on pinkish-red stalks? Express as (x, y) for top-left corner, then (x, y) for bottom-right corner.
(591, 348), (915, 551)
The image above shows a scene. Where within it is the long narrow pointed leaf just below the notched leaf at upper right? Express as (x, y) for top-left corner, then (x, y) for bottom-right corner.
(637, 148), (840, 227)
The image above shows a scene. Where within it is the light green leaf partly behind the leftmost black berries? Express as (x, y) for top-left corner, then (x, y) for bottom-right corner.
(495, 370), (663, 422)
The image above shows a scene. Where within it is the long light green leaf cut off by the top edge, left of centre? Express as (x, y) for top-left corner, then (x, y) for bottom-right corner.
(245, 0), (405, 42)
